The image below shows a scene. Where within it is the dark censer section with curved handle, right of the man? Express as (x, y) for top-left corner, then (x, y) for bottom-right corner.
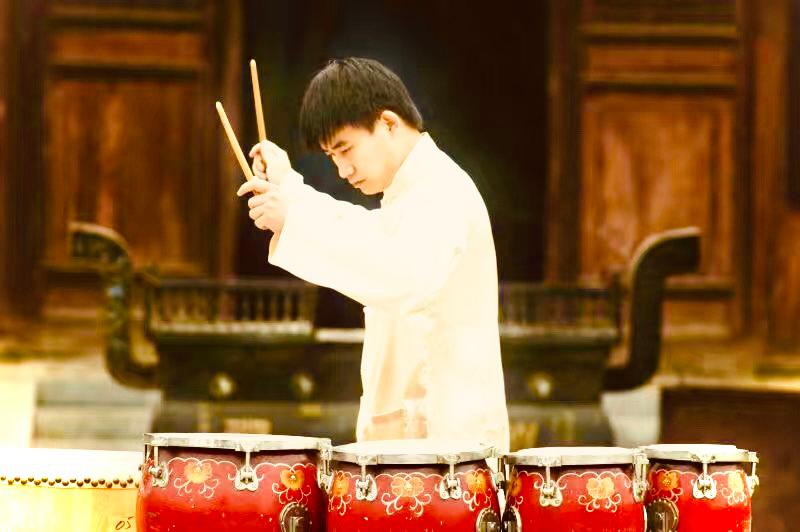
(500, 227), (700, 400)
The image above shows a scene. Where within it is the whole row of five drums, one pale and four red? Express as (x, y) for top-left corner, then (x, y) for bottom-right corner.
(0, 433), (758, 532)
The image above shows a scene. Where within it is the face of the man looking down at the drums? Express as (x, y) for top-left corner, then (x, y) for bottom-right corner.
(321, 120), (397, 195)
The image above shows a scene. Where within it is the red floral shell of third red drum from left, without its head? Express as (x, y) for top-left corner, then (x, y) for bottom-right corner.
(504, 464), (646, 532)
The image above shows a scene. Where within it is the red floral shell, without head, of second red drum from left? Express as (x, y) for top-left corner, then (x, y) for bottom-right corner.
(327, 460), (500, 532)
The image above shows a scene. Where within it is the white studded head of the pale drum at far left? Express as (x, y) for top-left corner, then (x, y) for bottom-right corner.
(0, 449), (142, 487)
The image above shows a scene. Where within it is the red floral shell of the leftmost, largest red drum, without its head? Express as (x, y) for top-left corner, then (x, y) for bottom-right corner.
(136, 446), (325, 532)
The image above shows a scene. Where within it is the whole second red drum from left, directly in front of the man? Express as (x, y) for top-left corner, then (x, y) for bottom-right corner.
(320, 440), (500, 532)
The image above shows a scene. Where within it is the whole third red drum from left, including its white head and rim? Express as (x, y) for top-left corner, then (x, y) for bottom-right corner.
(503, 447), (647, 532)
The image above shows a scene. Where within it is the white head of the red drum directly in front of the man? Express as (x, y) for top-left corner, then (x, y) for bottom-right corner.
(332, 439), (494, 465)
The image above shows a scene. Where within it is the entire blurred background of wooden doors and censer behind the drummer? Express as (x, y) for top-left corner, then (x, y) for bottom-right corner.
(0, 0), (800, 532)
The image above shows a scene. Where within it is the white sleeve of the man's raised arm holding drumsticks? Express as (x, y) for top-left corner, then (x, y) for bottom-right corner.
(269, 177), (468, 309)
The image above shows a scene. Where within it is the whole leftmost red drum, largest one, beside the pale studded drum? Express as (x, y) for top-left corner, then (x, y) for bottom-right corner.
(137, 433), (329, 532)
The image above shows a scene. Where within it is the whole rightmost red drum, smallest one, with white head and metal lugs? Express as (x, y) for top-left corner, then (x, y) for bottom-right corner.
(642, 445), (758, 532)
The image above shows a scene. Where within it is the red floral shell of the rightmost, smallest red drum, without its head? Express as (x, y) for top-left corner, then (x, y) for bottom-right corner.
(645, 458), (752, 532)
